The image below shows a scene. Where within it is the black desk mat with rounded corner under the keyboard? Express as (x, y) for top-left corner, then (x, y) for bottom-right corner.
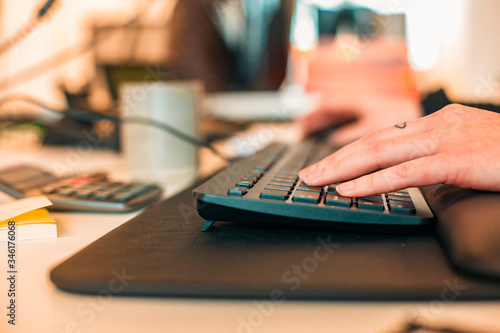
(50, 183), (500, 302)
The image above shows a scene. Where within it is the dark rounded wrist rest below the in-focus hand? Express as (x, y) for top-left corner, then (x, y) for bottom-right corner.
(422, 185), (500, 279)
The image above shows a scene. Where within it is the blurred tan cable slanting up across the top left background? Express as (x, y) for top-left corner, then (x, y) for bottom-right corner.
(0, 0), (175, 91)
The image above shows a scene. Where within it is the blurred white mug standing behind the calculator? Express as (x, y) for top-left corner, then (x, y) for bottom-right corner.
(120, 81), (204, 185)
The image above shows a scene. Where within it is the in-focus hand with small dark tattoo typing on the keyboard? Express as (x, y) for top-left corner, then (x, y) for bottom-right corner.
(299, 104), (500, 197)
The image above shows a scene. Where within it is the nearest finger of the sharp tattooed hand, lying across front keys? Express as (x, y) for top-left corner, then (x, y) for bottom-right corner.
(337, 155), (448, 197)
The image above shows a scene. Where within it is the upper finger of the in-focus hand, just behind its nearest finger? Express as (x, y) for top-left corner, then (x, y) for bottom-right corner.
(299, 132), (438, 186)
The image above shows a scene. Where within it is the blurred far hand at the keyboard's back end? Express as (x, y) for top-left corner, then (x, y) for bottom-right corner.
(299, 89), (424, 146)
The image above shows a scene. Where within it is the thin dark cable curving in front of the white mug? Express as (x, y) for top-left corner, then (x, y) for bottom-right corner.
(0, 94), (234, 163)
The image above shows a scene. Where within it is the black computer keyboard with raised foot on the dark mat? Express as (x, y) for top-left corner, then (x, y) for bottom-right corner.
(193, 141), (434, 233)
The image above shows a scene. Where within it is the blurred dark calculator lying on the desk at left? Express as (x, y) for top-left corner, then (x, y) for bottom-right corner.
(0, 165), (163, 212)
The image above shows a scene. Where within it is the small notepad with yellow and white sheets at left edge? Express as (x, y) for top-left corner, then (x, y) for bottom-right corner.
(0, 196), (57, 241)
